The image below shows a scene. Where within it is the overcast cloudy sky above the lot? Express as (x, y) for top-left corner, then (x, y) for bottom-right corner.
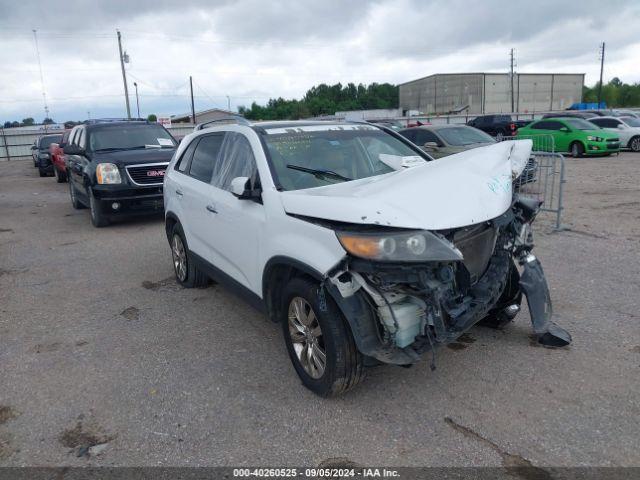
(0, 0), (640, 122)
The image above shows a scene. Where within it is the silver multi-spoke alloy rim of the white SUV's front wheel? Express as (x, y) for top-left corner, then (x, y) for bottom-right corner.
(288, 297), (327, 379)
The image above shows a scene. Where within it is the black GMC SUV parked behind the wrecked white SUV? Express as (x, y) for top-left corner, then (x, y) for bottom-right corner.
(64, 121), (177, 227)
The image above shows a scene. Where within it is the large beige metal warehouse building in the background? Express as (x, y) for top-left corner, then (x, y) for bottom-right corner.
(400, 73), (584, 114)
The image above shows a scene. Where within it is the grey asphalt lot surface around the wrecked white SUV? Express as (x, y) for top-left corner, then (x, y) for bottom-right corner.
(0, 153), (640, 467)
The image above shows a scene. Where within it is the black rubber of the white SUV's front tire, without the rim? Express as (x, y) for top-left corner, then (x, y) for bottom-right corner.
(281, 277), (364, 397)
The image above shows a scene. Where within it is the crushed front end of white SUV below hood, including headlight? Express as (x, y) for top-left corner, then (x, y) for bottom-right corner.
(323, 196), (571, 365)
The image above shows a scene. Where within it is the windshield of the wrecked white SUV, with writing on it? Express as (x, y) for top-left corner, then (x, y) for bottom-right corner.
(263, 125), (426, 190)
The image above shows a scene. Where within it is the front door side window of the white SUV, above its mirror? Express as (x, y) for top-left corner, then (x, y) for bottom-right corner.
(211, 132), (256, 190)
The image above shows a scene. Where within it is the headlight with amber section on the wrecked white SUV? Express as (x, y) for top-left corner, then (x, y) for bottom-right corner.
(336, 231), (462, 262)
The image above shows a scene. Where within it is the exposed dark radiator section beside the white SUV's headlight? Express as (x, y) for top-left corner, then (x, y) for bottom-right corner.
(453, 224), (497, 284)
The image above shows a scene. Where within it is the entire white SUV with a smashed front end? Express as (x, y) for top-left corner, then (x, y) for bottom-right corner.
(164, 119), (571, 396)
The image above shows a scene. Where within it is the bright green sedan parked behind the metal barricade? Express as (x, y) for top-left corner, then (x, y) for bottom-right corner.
(517, 117), (620, 157)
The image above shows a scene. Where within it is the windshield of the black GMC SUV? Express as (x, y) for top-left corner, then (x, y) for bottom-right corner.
(88, 124), (176, 152)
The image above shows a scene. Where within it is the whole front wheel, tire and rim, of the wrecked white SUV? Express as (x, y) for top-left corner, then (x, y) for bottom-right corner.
(281, 277), (364, 397)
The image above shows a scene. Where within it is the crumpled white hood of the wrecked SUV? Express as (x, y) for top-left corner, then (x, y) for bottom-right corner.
(280, 140), (532, 230)
